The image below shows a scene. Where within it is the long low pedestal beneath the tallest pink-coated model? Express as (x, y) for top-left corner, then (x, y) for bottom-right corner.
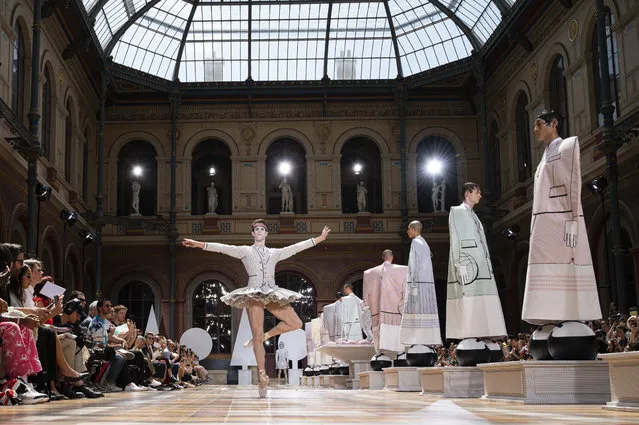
(478, 360), (611, 404)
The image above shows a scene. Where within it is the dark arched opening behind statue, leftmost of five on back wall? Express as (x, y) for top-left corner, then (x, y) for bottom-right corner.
(117, 140), (158, 216)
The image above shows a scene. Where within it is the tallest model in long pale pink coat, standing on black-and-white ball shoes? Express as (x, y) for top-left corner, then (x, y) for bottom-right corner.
(522, 111), (601, 360)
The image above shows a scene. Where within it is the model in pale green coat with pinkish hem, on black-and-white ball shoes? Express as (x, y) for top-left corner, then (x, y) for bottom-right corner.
(446, 182), (506, 366)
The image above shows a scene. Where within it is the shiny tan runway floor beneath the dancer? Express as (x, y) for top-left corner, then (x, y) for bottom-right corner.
(0, 385), (639, 425)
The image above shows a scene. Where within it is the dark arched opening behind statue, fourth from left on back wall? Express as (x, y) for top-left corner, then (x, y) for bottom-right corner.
(340, 137), (383, 214)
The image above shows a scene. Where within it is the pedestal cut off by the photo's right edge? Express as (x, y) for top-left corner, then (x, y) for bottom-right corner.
(599, 351), (639, 412)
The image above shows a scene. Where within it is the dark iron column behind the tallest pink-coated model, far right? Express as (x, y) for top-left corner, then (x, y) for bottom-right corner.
(595, 0), (628, 313)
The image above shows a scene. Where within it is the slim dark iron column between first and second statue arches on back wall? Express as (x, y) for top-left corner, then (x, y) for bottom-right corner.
(167, 93), (180, 338)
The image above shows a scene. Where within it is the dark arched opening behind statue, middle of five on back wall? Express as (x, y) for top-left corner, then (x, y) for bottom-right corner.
(266, 138), (307, 214)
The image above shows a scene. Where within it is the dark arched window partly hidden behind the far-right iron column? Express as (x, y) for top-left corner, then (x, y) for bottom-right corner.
(592, 8), (621, 126)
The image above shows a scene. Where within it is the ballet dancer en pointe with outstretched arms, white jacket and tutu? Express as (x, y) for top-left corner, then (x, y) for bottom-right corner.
(182, 219), (331, 397)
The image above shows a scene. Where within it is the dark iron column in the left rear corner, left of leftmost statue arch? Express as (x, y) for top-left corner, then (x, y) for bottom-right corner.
(95, 66), (109, 298)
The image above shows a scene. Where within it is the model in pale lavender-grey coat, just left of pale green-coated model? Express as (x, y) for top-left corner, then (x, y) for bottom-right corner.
(399, 221), (442, 366)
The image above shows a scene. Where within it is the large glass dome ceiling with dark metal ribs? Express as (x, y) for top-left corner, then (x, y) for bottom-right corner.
(83, 0), (515, 82)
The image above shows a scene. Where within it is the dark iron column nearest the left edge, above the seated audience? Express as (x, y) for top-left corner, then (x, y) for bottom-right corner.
(27, 0), (42, 258)
